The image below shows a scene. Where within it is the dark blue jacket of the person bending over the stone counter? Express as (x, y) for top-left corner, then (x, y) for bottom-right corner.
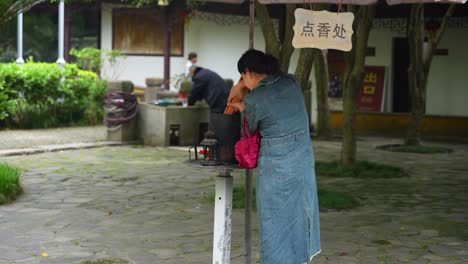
(188, 67), (229, 113)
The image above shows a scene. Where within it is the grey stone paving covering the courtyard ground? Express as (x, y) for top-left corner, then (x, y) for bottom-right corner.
(0, 138), (468, 264)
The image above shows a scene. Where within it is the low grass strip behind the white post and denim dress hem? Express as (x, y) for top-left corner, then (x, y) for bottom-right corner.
(209, 186), (359, 210)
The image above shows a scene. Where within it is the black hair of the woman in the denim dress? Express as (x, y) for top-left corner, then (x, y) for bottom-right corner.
(237, 49), (280, 75)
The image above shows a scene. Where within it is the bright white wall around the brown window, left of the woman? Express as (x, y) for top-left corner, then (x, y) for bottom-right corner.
(101, 4), (265, 87)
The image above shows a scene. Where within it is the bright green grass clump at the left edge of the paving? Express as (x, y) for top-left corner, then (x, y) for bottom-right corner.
(0, 163), (21, 204)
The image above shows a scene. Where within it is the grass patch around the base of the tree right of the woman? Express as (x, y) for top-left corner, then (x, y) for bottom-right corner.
(315, 160), (408, 179)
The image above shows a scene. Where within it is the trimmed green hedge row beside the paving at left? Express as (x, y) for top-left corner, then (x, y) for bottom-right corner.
(0, 62), (106, 128)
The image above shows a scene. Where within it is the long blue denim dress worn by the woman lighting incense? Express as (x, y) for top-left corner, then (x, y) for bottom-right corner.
(244, 75), (320, 264)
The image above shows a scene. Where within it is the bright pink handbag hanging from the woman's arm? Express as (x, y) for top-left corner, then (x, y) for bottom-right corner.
(234, 116), (260, 169)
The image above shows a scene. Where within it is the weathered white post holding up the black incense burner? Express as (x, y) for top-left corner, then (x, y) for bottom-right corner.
(213, 171), (233, 264)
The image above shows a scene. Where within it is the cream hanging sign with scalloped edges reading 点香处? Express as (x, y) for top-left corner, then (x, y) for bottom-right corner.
(292, 8), (354, 51)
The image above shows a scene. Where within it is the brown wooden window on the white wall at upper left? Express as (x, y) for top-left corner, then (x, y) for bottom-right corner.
(112, 8), (184, 56)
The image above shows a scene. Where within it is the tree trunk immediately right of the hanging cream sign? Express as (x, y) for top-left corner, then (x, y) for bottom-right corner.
(341, 5), (375, 167)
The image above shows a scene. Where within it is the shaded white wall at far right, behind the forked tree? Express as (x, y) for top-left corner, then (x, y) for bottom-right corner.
(366, 25), (468, 116)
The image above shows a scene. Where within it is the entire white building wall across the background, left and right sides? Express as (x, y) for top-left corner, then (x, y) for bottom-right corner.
(101, 4), (468, 117)
